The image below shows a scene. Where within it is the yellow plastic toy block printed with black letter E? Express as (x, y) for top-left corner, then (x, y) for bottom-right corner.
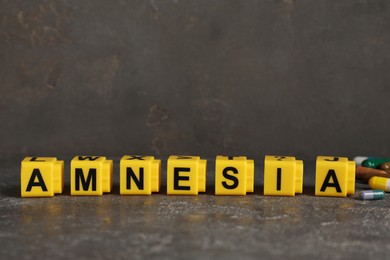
(167, 156), (206, 195)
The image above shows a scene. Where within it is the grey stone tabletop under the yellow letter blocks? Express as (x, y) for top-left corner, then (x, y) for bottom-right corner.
(0, 158), (390, 259)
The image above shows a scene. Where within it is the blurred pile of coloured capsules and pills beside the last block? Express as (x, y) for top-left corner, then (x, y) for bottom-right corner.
(354, 156), (390, 200)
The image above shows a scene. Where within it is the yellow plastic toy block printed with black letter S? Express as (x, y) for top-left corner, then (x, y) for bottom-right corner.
(215, 155), (255, 195)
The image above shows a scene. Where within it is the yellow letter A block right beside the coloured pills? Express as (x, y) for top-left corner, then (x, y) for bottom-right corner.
(315, 156), (356, 197)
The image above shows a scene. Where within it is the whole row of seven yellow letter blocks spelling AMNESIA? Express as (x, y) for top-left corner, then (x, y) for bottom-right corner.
(20, 155), (356, 197)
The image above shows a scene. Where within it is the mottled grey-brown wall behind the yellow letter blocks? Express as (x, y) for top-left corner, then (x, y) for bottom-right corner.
(0, 0), (390, 160)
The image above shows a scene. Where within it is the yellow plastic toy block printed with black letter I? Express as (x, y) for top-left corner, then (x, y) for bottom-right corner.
(264, 155), (303, 196)
